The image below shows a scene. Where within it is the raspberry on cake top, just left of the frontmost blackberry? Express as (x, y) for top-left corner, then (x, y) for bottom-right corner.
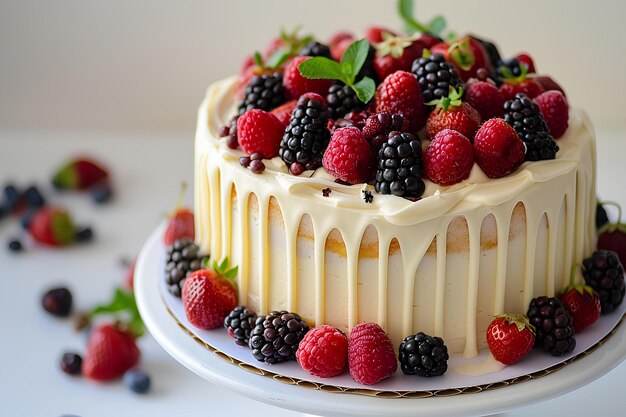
(322, 127), (374, 184)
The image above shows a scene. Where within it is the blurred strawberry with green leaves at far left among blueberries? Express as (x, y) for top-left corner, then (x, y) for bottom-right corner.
(28, 206), (76, 246)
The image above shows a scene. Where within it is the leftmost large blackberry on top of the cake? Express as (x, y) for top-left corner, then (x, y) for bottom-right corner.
(237, 72), (285, 116)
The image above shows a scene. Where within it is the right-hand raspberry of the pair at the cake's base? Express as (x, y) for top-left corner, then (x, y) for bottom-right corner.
(348, 323), (398, 385)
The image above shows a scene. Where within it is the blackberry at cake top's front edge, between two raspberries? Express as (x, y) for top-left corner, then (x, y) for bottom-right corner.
(375, 132), (424, 197)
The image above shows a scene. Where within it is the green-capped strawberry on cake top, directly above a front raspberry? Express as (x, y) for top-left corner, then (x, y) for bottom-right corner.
(426, 86), (481, 141)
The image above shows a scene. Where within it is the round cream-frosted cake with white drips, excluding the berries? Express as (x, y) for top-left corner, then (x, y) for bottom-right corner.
(195, 78), (596, 357)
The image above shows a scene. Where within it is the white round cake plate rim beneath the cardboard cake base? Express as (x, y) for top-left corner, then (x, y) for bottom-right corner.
(135, 225), (626, 416)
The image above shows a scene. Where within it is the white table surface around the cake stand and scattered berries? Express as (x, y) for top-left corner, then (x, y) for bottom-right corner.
(0, 130), (626, 417)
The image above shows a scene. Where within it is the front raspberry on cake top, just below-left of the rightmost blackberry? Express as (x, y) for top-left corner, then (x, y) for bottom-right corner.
(474, 119), (524, 178)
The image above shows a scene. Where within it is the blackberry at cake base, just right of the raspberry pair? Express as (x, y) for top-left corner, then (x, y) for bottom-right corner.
(399, 332), (449, 377)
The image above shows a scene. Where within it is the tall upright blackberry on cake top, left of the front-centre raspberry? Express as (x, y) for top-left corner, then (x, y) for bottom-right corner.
(278, 94), (330, 169)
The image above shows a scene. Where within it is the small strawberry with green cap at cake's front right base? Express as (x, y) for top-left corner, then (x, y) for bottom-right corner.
(487, 314), (535, 365)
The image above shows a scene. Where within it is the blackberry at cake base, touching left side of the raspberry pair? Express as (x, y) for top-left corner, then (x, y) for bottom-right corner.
(249, 311), (309, 364)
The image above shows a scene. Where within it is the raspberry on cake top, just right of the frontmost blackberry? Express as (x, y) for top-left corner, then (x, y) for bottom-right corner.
(424, 129), (474, 185)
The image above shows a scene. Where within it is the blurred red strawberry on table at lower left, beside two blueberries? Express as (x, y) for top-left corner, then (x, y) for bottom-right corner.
(82, 324), (140, 381)
